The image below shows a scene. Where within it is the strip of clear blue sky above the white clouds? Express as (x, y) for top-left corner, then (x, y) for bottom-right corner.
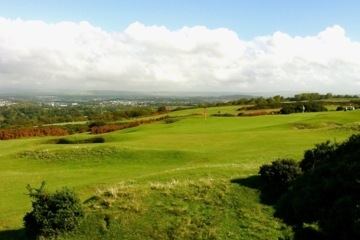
(0, 0), (360, 41)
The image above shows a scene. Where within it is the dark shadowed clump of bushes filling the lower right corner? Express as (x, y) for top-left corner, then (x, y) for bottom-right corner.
(259, 135), (360, 240)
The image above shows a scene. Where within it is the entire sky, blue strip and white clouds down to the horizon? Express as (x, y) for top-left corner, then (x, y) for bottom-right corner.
(0, 0), (360, 94)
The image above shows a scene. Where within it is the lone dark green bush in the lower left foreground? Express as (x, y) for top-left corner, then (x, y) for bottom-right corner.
(23, 182), (84, 237)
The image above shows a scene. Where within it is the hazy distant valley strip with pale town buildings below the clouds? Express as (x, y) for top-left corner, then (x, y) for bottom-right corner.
(0, 91), (254, 107)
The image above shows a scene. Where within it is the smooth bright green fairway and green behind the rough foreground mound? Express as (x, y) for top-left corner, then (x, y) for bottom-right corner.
(0, 107), (360, 239)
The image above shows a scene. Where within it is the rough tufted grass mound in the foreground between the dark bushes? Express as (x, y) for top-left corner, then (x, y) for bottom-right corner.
(63, 178), (292, 239)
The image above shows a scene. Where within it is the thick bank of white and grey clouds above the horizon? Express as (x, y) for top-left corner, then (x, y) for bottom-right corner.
(0, 18), (360, 94)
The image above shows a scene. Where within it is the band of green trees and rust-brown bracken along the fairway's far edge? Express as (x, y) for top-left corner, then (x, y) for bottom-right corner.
(0, 93), (360, 140)
